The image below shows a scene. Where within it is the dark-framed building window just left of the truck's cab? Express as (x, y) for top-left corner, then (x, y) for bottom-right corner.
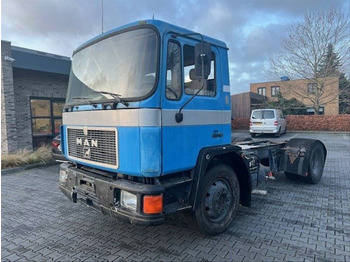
(30, 98), (64, 148)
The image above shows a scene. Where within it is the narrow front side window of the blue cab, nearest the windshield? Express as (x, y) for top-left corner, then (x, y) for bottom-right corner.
(165, 41), (182, 100)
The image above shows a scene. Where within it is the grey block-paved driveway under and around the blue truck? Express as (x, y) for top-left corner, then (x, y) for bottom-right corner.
(1, 133), (350, 261)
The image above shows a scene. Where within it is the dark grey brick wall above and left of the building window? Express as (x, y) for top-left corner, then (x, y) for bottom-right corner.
(13, 68), (68, 149)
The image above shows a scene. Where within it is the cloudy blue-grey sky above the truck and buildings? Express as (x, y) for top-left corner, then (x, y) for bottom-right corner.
(1, 0), (350, 94)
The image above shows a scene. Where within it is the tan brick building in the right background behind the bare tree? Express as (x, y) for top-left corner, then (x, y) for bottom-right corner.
(250, 77), (339, 115)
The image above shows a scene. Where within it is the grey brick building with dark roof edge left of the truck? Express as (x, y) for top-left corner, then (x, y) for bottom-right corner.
(1, 40), (71, 153)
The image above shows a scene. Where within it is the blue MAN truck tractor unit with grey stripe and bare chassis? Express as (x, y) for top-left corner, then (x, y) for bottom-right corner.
(59, 20), (326, 235)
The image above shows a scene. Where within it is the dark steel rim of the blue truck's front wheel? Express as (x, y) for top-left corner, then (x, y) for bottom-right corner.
(205, 179), (232, 221)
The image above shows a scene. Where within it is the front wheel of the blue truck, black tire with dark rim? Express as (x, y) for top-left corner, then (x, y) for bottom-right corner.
(185, 165), (240, 235)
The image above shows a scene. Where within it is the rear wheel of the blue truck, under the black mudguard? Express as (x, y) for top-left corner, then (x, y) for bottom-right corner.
(303, 143), (325, 184)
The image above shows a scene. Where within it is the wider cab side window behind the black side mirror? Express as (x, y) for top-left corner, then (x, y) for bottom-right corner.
(183, 45), (216, 97)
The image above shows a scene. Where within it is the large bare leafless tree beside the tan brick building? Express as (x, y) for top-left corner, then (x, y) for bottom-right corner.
(268, 10), (350, 114)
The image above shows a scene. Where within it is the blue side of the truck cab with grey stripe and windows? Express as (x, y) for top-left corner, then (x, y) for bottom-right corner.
(161, 34), (224, 174)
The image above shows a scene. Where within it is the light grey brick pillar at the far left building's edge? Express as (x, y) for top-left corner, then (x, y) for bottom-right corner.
(1, 41), (17, 153)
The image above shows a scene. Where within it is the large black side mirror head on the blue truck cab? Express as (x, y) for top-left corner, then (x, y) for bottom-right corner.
(194, 42), (211, 79)
